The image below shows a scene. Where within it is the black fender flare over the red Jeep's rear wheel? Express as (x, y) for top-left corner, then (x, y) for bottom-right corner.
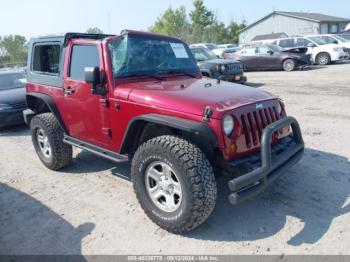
(25, 92), (68, 134)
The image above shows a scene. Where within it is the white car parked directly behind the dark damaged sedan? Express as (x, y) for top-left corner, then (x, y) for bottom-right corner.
(272, 36), (349, 65)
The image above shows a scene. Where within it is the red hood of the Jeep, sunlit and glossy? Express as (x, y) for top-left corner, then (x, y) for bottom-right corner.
(116, 78), (276, 119)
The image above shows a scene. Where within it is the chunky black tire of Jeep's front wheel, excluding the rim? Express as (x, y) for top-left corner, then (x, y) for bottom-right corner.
(131, 136), (217, 234)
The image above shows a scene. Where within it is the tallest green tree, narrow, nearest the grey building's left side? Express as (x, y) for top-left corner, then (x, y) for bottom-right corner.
(190, 0), (216, 42)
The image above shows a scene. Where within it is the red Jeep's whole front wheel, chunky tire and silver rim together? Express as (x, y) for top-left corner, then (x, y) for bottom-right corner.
(131, 136), (217, 234)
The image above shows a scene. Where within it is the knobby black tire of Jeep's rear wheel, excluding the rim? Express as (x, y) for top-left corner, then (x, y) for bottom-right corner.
(30, 113), (73, 170)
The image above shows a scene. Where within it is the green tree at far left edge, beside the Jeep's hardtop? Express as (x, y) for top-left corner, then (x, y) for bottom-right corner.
(0, 35), (27, 63)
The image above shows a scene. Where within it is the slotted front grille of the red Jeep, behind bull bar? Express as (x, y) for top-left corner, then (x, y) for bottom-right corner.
(241, 106), (281, 148)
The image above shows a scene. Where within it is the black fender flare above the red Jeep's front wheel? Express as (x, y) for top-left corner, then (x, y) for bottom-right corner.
(120, 114), (217, 154)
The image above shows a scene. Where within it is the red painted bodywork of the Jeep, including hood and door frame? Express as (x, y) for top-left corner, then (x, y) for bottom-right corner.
(27, 37), (288, 159)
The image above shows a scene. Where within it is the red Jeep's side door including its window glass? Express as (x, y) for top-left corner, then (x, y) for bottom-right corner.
(60, 40), (111, 148)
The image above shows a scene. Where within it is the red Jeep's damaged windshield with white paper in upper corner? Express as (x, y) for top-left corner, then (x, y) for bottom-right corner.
(109, 35), (199, 77)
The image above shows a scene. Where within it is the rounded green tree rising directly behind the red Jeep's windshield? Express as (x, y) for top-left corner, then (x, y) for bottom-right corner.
(149, 6), (190, 41)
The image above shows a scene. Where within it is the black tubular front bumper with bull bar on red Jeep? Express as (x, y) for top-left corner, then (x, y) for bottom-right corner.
(228, 117), (304, 205)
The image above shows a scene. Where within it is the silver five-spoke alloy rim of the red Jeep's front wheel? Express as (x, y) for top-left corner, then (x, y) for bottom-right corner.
(145, 161), (182, 213)
